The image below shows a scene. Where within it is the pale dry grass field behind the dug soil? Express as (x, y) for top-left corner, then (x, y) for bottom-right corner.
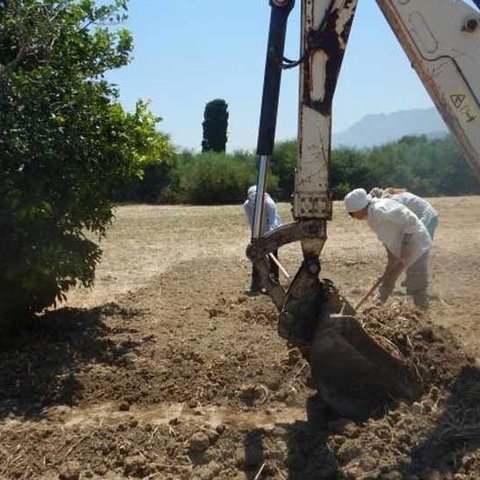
(67, 193), (480, 320)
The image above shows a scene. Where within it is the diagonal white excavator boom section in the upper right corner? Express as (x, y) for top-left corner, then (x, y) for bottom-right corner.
(377, 0), (480, 180)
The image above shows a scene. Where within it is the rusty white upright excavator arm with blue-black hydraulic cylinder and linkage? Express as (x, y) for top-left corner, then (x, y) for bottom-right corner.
(247, 0), (357, 334)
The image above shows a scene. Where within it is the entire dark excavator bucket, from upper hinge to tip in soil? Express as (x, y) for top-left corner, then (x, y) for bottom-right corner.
(279, 265), (420, 419)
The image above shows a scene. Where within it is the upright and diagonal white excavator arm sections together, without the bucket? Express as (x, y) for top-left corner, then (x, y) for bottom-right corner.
(247, 0), (480, 338)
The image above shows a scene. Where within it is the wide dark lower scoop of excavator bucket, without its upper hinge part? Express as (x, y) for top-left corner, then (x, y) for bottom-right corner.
(309, 314), (420, 419)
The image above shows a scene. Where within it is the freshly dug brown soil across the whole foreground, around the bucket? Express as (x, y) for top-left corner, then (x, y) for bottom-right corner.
(0, 255), (480, 480)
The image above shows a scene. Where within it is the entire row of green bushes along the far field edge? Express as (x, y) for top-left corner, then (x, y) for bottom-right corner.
(125, 136), (479, 204)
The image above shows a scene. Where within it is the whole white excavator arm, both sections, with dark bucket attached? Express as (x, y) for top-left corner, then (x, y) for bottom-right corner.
(247, 0), (480, 417)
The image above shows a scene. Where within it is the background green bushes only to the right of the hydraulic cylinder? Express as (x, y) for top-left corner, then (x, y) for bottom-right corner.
(262, 136), (480, 200)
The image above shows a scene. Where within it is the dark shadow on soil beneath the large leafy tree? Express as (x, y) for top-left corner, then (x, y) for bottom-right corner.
(0, 303), (144, 419)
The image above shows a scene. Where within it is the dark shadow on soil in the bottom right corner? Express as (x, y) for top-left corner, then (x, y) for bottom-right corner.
(397, 366), (480, 478)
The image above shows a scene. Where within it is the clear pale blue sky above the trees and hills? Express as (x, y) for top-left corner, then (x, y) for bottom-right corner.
(109, 0), (446, 152)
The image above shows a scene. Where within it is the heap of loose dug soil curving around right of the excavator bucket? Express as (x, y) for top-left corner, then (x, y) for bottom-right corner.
(295, 305), (480, 480)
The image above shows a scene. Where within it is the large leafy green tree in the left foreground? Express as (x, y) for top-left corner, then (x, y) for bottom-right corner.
(0, 0), (173, 321)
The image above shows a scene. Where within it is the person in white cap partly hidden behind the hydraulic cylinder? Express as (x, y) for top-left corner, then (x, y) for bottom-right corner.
(243, 185), (282, 295)
